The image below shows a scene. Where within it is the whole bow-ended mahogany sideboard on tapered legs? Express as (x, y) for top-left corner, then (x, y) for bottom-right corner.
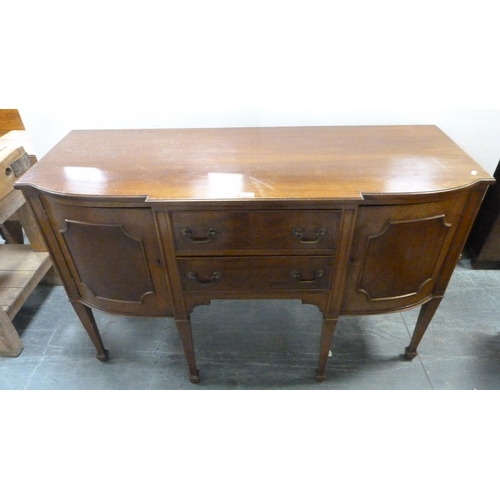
(16, 126), (494, 382)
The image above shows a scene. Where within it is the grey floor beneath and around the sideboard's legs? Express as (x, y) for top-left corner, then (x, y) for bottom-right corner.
(0, 259), (500, 390)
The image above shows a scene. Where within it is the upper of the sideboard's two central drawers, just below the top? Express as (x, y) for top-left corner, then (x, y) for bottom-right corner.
(172, 210), (341, 253)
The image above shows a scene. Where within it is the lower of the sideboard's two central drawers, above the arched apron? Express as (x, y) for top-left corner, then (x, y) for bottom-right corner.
(178, 256), (332, 292)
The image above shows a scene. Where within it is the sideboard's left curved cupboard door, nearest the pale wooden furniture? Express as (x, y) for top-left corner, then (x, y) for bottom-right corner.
(42, 197), (173, 316)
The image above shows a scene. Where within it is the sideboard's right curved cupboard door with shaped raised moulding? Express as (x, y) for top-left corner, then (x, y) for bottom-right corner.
(341, 193), (468, 314)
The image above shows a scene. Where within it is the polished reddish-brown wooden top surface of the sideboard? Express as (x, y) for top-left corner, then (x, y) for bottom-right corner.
(16, 126), (493, 201)
